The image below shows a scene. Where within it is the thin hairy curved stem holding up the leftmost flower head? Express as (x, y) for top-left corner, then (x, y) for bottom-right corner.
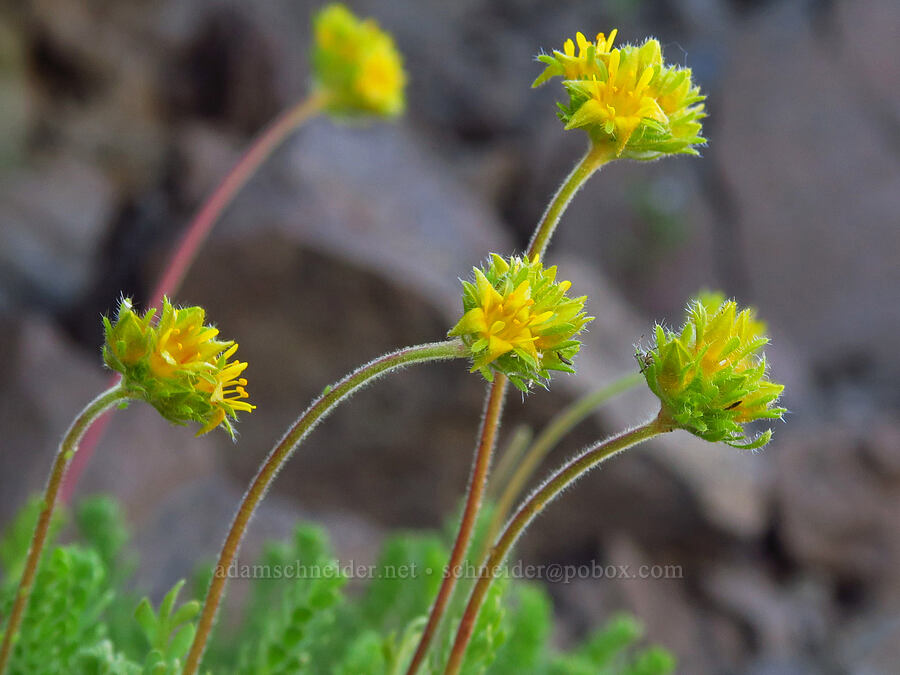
(0, 384), (128, 674)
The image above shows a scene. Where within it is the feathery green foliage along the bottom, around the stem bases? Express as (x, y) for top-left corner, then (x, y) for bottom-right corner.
(0, 498), (674, 675)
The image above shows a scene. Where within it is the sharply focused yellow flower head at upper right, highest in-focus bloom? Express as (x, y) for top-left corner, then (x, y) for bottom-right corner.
(533, 30), (705, 160)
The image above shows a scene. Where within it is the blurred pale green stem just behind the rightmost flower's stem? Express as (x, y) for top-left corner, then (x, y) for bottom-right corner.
(475, 373), (644, 561)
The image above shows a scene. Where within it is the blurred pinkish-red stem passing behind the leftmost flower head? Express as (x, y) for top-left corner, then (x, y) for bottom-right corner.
(62, 94), (327, 502)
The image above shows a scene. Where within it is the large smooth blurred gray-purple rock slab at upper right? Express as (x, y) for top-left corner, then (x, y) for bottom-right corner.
(709, 3), (900, 386)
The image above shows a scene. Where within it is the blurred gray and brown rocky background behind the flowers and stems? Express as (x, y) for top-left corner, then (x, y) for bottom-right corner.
(0, 0), (900, 675)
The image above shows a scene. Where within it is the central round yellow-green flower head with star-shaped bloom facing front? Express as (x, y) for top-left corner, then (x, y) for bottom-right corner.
(449, 254), (593, 391)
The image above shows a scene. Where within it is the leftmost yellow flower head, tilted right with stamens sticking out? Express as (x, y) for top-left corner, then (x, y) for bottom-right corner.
(103, 298), (256, 438)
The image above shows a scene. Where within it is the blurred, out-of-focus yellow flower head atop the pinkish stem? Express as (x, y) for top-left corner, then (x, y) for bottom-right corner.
(312, 4), (406, 117)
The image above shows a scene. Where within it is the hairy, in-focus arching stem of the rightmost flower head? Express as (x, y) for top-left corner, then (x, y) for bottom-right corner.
(444, 415), (671, 675)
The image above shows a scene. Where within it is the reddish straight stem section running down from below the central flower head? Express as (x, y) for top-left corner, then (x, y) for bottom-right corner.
(406, 373), (506, 675)
